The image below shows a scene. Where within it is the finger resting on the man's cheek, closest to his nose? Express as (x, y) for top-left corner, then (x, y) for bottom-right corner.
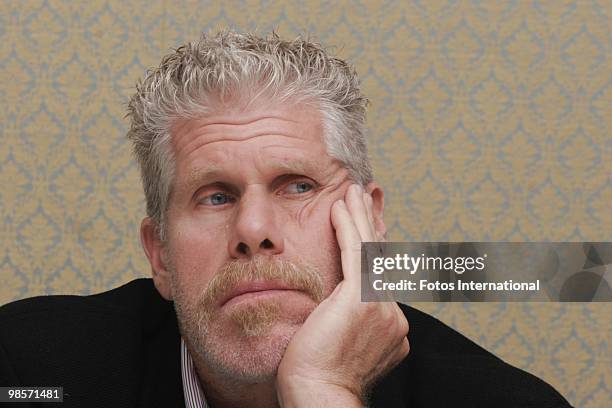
(331, 200), (361, 284)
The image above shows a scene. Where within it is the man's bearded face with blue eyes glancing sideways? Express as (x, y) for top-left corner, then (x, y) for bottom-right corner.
(156, 102), (350, 381)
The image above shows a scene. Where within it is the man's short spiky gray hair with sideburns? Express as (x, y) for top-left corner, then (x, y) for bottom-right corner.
(127, 31), (372, 241)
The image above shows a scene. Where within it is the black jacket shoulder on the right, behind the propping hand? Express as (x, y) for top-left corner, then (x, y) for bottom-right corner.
(372, 304), (570, 408)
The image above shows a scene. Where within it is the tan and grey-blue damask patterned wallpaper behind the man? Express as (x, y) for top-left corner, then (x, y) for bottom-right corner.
(0, 0), (612, 407)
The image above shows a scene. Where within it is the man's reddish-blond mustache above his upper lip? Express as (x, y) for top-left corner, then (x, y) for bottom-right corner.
(200, 255), (324, 313)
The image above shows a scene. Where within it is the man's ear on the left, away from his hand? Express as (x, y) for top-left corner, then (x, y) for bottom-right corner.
(140, 218), (172, 300)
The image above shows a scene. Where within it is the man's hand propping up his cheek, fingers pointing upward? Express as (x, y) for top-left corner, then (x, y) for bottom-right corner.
(276, 185), (409, 407)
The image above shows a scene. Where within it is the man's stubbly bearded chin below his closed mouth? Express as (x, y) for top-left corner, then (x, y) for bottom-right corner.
(177, 296), (316, 384)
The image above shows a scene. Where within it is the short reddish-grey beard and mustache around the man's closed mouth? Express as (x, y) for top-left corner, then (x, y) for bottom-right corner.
(170, 255), (340, 384)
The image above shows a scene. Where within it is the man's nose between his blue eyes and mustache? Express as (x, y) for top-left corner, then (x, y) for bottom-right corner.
(228, 186), (284, 258)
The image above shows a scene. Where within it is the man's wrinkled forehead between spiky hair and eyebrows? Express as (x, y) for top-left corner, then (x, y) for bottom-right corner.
(171, 105), (331, 183)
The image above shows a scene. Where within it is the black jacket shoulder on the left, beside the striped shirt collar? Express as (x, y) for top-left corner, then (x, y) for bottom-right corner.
(0, 279), (180, 406)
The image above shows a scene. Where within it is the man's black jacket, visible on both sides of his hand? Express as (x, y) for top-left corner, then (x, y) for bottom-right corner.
(0, 279), (569, 408)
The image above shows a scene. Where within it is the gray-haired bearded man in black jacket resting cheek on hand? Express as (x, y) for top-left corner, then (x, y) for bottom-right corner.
(0, 32), (567, 407)
